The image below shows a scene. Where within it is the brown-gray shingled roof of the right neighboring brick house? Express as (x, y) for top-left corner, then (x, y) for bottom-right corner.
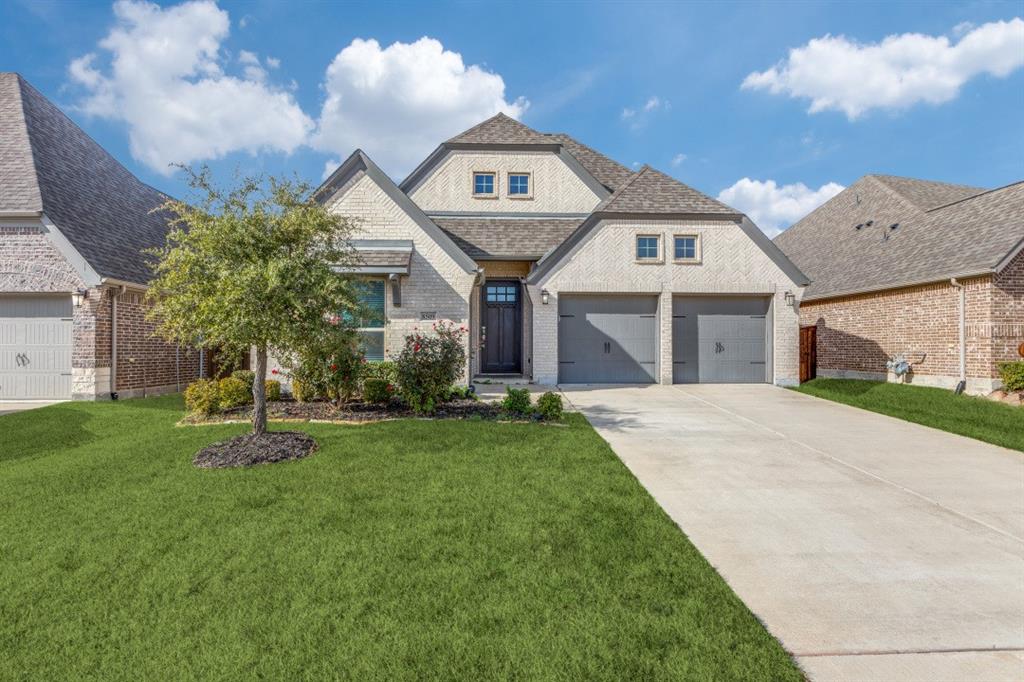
(775, 175), (1024, 300)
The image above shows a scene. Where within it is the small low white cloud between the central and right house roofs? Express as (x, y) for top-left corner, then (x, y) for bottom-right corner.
(718, 177), (845, 237)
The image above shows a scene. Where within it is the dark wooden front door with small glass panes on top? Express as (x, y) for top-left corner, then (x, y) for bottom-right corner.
(480, 280), (522, 374)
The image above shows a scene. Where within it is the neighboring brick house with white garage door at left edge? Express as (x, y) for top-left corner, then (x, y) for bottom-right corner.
(0, 73), (200, 400)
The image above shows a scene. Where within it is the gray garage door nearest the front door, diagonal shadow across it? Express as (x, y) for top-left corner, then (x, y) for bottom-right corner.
(558, 295), (657, 384)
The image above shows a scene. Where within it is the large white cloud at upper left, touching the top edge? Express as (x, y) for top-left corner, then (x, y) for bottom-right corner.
(69, 0), (313, 174)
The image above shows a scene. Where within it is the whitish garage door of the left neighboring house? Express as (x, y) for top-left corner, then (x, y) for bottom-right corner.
(0, 294), (72, 400)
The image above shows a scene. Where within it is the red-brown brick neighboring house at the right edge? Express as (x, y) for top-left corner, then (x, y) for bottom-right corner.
(775, 175), (1024, 393)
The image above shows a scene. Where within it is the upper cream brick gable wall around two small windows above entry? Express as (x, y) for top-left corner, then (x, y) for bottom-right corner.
(410, 151), (601, 213)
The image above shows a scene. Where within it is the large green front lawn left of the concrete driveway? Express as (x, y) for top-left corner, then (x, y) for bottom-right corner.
(0, 396), (801, 680)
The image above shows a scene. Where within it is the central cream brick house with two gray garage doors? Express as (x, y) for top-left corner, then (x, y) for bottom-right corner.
(314, 114), (807, 385)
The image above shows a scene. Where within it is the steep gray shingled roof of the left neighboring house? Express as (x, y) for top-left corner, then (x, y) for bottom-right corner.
(0, 73), (167, 284)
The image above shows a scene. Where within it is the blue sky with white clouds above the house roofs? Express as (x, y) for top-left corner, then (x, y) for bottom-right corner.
(0, 0), (1024, 233)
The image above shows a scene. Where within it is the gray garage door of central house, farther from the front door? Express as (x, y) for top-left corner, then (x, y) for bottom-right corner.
(672, 296), (771, 384)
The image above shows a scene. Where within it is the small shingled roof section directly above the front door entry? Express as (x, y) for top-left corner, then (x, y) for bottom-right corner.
(433, 217), (583, 260)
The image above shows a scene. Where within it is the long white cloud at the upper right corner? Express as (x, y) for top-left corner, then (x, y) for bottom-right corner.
(741, 17), (1024, 120)
